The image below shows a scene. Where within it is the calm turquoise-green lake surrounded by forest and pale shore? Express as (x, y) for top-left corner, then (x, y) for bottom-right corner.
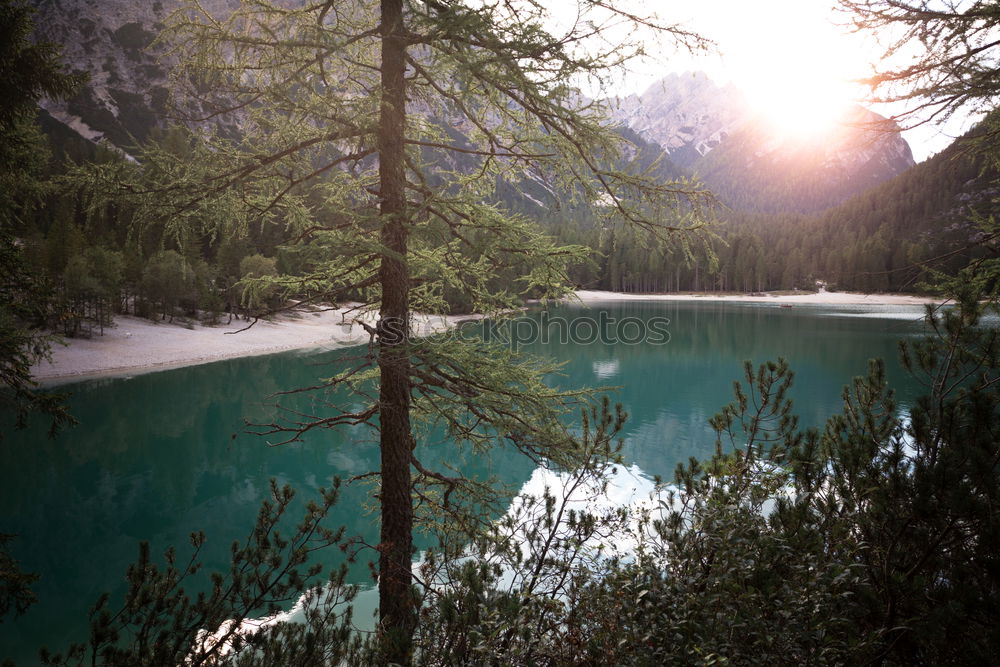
(0, 301), (924, 664)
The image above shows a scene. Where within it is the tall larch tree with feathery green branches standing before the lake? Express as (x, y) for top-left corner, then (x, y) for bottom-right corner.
(86, 0), (707, 664)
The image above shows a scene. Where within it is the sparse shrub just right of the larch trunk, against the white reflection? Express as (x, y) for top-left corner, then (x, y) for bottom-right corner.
(400, 400), (629, 665)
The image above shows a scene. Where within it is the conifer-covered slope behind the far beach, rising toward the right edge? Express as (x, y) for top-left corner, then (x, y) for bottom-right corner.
(562, 123), (1000, 292)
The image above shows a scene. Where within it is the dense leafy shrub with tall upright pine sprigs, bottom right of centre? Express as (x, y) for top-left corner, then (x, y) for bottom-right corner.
(436, 363), (855, 665)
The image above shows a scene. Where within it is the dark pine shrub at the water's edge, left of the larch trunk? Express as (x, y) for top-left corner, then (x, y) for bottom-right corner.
(42, 480), (360, 667)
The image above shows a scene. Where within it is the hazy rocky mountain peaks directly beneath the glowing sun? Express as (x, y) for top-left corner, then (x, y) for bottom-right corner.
(608, 72), (914, 213)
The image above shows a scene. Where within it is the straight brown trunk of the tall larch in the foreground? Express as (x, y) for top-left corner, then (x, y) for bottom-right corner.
(378, 0), (415, 665)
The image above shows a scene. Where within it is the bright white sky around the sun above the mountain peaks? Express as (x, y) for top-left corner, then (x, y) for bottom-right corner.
(584, 0), (969, 161)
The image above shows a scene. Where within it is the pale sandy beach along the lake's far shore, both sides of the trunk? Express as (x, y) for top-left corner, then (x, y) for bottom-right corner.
(32, 290), (935, 385)
